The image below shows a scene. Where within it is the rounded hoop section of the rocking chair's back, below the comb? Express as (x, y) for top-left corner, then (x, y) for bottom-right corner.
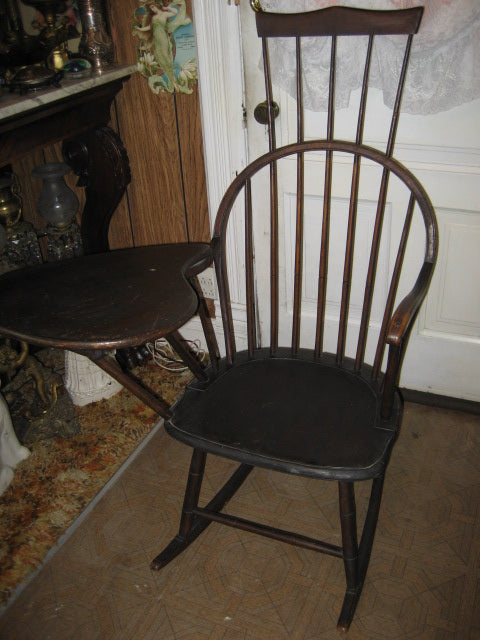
(212, 140), (438, 412)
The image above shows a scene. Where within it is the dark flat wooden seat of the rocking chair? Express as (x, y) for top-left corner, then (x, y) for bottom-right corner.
(166, 350), (401, 480)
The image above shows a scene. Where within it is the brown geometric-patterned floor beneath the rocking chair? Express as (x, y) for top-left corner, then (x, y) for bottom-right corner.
(0, 404), (480, 640)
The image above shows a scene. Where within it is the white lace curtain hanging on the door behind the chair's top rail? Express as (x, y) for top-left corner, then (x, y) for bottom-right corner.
(261, 0), (480, 114)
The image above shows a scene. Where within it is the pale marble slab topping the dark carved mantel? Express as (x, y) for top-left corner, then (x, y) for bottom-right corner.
(0, 65), (137, 122)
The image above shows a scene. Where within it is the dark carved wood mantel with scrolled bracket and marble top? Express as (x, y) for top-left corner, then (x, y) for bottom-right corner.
(0, 66), (135, 253)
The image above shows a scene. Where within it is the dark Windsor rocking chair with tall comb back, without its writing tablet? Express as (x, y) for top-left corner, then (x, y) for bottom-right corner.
(152, 2), (437, 631)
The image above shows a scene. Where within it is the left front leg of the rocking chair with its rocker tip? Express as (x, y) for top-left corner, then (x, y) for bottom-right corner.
(150, 449), (208, 571)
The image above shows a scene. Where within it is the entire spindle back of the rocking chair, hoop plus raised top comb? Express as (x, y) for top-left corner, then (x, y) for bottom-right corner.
(208, 7), (437, 416)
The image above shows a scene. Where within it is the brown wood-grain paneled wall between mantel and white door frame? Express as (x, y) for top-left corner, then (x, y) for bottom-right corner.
(12, 0), (210, 254)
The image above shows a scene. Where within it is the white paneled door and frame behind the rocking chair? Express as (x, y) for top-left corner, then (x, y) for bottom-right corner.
(195, 0), (480, 401)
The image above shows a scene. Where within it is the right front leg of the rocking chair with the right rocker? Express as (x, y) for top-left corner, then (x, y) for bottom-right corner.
(337, 474), (385, 632)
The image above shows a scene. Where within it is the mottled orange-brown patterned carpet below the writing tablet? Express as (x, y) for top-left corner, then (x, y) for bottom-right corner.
(0, 356), (191, 609)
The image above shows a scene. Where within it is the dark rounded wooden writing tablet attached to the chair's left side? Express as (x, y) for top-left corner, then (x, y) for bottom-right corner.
(0, 243), (211, 350)
